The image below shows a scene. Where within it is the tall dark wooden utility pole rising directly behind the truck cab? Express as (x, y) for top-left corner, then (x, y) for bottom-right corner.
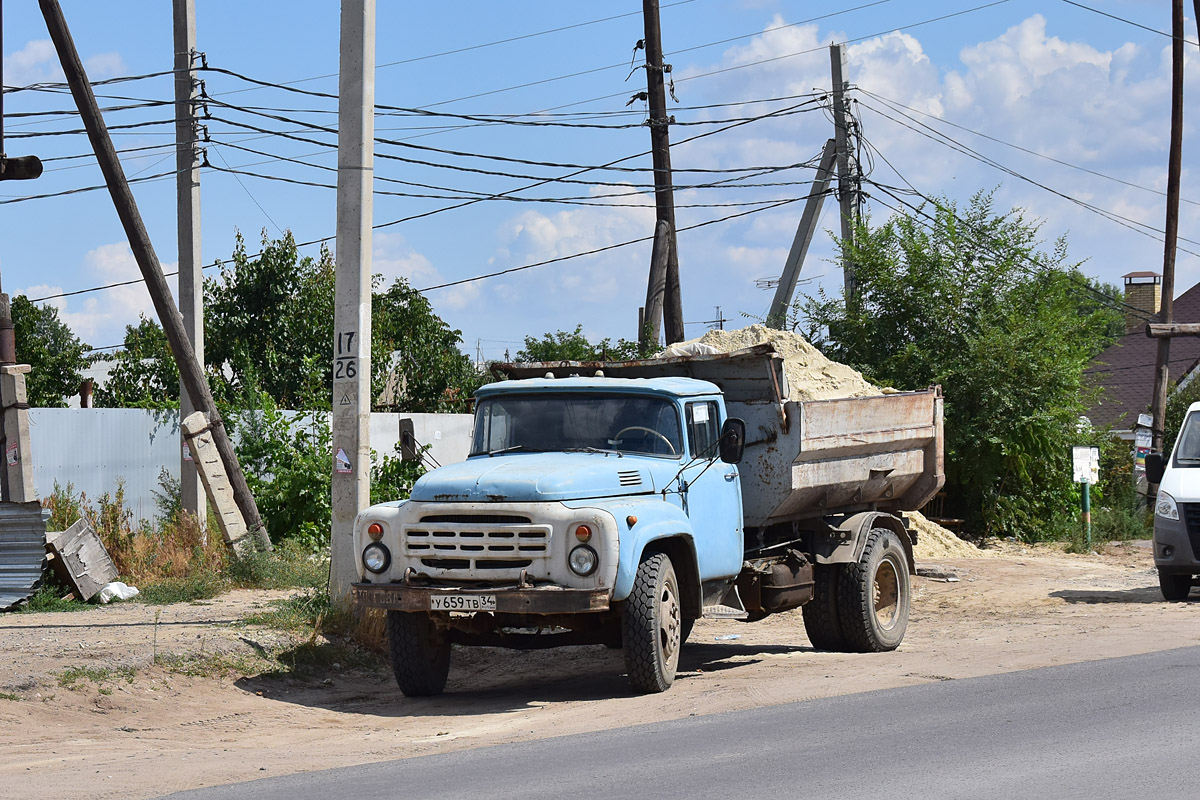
(642, 0), (684, 344)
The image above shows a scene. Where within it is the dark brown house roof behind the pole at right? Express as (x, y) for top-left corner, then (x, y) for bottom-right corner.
(1084, 283), (1200, 431)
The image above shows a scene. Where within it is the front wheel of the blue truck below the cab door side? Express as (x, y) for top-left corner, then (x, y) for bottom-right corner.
(620, 553), (683, 694)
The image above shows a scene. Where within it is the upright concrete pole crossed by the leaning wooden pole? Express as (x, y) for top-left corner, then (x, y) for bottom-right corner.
(172, 0), (208, 531)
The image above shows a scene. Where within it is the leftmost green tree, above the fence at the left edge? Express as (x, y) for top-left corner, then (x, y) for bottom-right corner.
(12, 295), (91, 408)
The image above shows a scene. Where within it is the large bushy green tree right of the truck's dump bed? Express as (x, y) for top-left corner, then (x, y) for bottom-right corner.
(803, 192), (1121, 537)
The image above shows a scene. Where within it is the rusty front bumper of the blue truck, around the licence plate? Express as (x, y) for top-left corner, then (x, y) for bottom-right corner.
(350, 583), (608, 614)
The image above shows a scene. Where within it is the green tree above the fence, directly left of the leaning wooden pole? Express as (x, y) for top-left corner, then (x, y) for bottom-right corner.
(95, 317), (179, 409)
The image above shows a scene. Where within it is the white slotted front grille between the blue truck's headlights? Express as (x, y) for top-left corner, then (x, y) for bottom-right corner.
(401, 515), (551, 570)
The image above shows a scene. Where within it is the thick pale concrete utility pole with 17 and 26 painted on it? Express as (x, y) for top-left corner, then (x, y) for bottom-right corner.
(329, 0), (376, 603)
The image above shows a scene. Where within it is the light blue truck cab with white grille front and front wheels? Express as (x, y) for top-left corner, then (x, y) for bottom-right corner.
(354, 377), (743, 694)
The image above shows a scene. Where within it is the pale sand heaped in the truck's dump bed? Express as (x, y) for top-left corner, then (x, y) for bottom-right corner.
(667, 325), (889, 401)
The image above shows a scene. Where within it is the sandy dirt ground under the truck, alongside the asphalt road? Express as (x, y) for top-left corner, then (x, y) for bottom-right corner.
(0, 543), (1200, 800)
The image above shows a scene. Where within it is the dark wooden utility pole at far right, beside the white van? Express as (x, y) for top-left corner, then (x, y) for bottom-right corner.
(1150, 0), (1183, 452)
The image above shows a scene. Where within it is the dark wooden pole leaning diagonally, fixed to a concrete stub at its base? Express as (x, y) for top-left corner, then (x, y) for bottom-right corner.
(38, 0), (271, 549)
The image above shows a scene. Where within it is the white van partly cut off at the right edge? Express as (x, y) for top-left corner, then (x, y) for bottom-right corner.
(1146, 403), (1200, 600)
